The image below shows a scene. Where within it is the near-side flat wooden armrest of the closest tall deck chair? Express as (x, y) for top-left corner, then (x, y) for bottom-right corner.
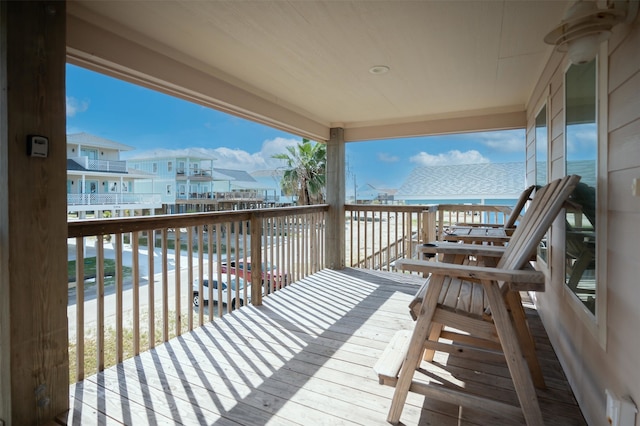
(396, 259), (545, 291)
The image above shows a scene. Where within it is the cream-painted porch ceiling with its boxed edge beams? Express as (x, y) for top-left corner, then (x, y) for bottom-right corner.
(67, 0), (568, 140)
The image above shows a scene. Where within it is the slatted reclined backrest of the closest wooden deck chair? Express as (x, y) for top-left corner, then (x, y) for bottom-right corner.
(497, 175), (580, 269)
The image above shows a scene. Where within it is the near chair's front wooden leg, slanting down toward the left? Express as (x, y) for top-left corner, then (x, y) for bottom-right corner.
(387, 275), (444, 424)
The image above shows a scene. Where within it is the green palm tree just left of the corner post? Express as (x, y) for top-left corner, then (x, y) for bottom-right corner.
(272, 139), (327, 205)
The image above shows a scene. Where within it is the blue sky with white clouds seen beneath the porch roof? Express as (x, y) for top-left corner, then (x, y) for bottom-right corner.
(67, 65), (525, 188)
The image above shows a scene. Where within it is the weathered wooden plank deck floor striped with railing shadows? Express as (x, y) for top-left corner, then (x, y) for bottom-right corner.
(60, 269), (585, 426)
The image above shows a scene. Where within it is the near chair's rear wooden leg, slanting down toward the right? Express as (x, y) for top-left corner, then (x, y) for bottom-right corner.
(482, 281), (544, 426)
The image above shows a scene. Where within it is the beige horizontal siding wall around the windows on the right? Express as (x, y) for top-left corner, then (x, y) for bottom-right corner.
(527, 18), (640, 425)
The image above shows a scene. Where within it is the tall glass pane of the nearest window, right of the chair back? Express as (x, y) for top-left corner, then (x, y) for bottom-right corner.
(565, 60), (598, 314)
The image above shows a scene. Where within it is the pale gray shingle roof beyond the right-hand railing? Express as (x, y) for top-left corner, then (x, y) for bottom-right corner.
(395, 162), (525, 200)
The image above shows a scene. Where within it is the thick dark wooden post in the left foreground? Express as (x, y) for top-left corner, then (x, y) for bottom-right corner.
(0, 1), (69, 425)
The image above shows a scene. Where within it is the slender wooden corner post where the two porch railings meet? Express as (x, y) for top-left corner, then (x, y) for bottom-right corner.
(325, 127), (345, 269)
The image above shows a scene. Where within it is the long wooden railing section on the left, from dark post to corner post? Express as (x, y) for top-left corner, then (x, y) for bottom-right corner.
(68, 205), (328, 382)
